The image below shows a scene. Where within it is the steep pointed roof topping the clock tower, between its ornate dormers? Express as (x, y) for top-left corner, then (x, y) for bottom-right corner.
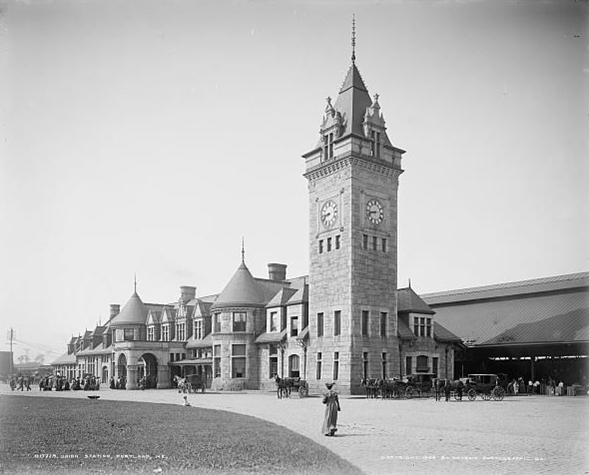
(334, 63), (372, 137)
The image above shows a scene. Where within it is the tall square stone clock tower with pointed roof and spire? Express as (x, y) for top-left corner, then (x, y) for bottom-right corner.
(303, 37), (405, 394)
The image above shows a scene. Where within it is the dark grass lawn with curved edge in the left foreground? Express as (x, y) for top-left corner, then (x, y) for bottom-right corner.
(0, 395), (362, 475)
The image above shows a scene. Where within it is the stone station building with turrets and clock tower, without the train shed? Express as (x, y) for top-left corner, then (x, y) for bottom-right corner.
(53, 48), (461, 394)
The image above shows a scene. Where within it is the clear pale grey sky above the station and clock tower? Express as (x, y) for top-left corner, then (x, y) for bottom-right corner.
(0, 0), (589, 362)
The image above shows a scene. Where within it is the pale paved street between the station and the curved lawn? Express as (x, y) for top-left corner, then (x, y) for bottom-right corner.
(1, 386), (589, 475)
